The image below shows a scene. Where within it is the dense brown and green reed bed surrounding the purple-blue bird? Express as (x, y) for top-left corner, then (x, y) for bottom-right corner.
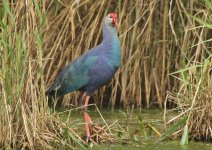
(0, 0), (212, 149)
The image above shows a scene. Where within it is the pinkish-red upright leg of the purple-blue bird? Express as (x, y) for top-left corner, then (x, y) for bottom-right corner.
(84, 96), (92, 140)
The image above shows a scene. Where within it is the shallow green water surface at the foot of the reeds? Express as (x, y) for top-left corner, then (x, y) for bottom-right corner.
(58, 107), (212, 150)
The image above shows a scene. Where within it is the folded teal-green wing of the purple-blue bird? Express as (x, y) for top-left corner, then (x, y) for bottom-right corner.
(47, 54), (97, 96)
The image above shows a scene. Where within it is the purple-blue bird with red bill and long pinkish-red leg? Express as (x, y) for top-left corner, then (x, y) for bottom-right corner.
(46, 12), (121, 140)
